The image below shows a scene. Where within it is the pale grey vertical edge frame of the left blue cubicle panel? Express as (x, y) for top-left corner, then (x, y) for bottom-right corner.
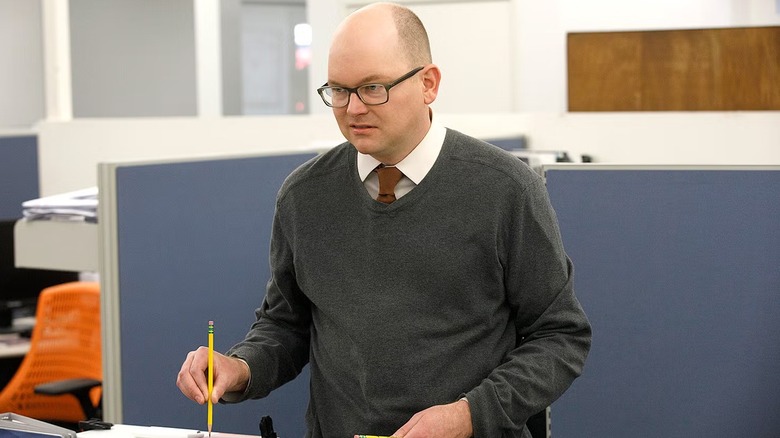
(98, 163), (122, 423)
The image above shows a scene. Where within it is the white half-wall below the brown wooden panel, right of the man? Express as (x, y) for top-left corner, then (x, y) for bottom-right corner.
(508, 111), (780, 165)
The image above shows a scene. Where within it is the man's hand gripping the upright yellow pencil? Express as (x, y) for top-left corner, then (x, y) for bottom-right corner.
(176, 347), (249, 404)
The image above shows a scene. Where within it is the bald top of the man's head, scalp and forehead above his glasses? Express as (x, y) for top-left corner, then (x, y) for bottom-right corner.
(331, 2), (432, 68)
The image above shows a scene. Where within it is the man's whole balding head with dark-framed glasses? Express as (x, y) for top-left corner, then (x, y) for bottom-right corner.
(320, 3), (441, 164)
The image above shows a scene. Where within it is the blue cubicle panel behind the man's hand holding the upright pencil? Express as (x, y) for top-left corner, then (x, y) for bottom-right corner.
(100, 154), (314, 437)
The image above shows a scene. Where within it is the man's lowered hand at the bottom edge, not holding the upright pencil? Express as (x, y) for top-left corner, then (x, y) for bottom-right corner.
(393, 400), (473, 438)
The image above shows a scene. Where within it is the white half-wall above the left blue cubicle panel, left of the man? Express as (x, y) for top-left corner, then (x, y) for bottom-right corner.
(37, 115), (342, 196)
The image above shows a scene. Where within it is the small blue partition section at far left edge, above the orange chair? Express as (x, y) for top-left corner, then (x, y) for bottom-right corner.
(0, 134), (40, 220)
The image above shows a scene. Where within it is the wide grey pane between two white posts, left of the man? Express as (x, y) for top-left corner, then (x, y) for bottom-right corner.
(70, 0), (197, 117)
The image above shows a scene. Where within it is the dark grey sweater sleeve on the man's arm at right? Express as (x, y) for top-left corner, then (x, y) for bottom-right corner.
(466, 180), (591, 438)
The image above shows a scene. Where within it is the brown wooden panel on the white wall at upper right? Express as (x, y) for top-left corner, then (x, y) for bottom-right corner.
(567, 26), (780, 111)
